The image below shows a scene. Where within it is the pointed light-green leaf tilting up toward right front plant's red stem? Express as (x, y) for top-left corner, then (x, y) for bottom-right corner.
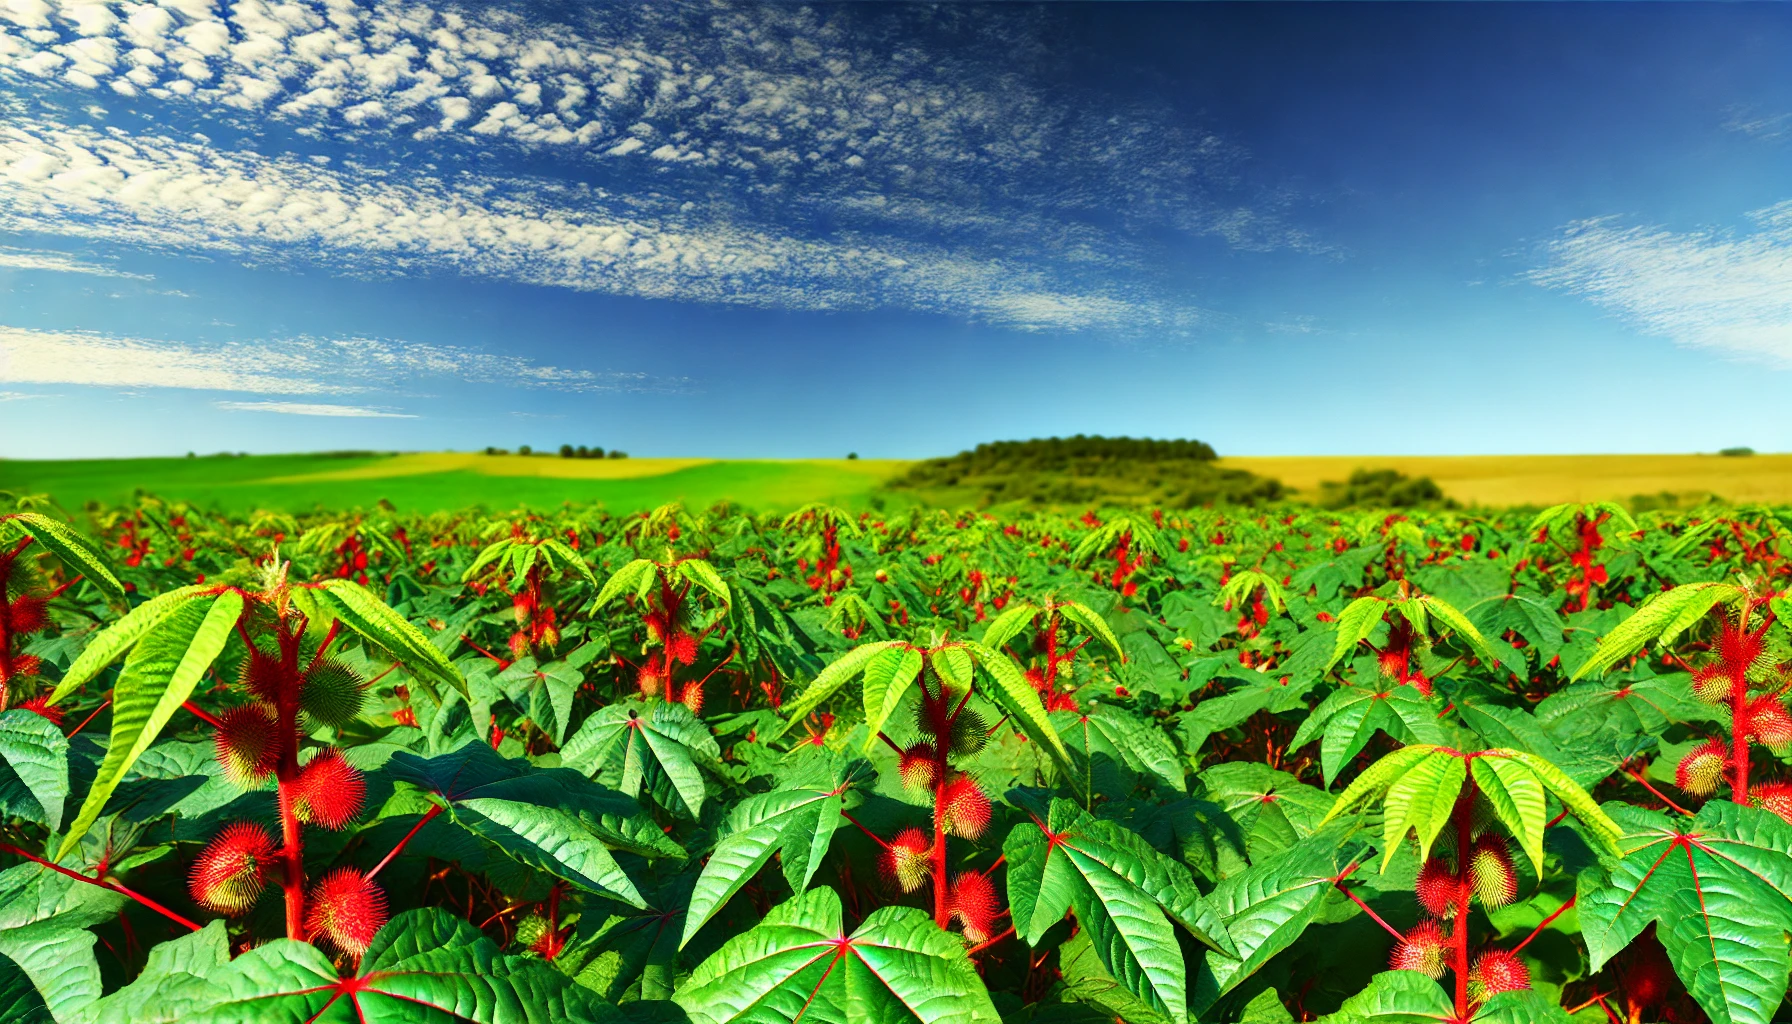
(1190, 827), (1366, 1015)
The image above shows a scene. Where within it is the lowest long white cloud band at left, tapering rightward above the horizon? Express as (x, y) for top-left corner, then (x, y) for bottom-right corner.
(0, 326), (690, 395)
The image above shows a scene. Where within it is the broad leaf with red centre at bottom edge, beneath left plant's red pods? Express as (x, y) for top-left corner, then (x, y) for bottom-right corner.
(183, 909), (618, 1024)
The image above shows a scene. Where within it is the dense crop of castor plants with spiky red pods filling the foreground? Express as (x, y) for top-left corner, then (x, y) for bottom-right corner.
(0, 499), (1792, 1024)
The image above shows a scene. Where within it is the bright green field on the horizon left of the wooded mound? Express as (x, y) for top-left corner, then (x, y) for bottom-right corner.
(0, 452), (907, 513)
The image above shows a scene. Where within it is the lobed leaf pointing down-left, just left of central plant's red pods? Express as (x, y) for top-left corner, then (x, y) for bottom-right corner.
(679, 759), (876, 949)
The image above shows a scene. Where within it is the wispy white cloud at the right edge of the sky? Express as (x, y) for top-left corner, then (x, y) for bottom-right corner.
(1529, 201), (1792, 366)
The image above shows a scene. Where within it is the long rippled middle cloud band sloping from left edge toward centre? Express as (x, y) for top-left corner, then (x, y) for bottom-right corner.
(0, 117), (1175, 330)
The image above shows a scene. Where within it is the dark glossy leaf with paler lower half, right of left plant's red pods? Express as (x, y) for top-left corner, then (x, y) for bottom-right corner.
(385, 742), (683, 906)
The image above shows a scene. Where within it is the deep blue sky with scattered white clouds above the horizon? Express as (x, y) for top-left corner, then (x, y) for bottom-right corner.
(0, 0), (1792, 457)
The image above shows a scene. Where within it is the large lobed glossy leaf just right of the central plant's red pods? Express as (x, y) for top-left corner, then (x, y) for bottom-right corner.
(1002, 800), (1233, 1020)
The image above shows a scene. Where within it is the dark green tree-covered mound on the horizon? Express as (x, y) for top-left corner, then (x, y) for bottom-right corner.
(885, 434), (1288, 509)
